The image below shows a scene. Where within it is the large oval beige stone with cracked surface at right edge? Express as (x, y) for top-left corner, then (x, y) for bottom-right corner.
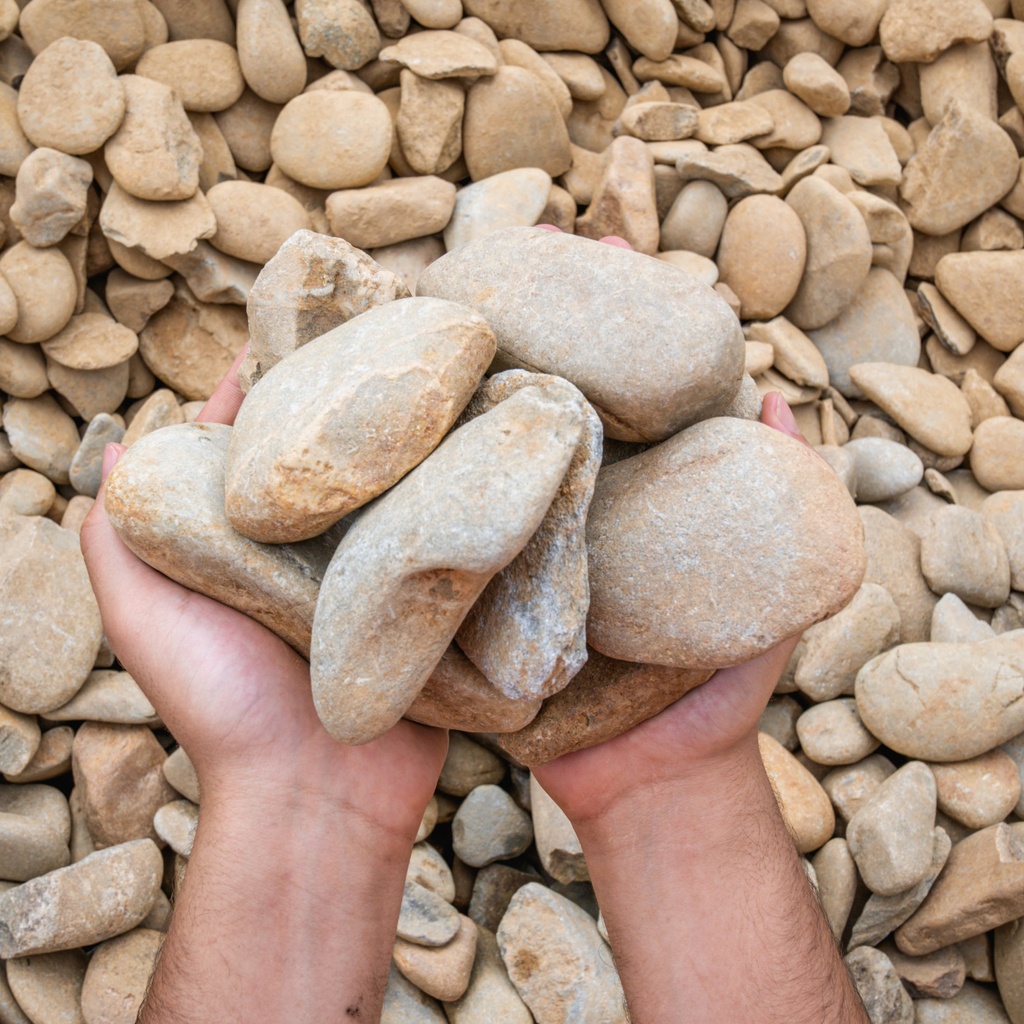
(856, 630), (1024, 761)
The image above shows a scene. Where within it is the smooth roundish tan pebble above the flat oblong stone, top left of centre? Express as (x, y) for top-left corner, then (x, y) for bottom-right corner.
(270, 90), (392, 189)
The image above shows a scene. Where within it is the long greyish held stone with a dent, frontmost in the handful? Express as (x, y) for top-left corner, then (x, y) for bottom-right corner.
(310, 387), (584, 743)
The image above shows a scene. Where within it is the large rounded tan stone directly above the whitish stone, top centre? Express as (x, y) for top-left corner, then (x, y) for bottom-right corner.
(466, 65), (571, 180)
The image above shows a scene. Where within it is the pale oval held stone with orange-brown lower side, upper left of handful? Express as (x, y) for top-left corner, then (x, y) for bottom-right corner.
(225, 299), (495, 544)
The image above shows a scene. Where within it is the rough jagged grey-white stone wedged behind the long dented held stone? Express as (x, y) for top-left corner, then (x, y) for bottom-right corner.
(456, 370), (602, 699)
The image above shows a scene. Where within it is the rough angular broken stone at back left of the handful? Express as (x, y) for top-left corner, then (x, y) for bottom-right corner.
(239, 230), (409, 391)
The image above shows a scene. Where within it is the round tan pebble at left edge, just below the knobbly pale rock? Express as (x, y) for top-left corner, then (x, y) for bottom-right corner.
(0, 242), (78, 342)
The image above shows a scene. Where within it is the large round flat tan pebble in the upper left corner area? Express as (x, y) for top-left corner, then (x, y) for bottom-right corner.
(17, 35), (125, 156)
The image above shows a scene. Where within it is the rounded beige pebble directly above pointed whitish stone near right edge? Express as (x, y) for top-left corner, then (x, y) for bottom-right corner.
(921, 505), (1010, 608)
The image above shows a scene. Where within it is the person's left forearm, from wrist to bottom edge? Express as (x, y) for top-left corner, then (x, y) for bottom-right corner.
(140, 778), (413, 1024)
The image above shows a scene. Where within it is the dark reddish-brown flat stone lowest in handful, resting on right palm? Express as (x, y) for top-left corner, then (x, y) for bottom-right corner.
(498, 648), (712, 765)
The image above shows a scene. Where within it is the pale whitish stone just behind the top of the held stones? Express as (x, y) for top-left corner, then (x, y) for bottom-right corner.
(442, 167), (552, 250)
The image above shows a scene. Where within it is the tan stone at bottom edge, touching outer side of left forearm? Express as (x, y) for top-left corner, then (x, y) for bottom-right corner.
(82, 928), (164, 1024)
